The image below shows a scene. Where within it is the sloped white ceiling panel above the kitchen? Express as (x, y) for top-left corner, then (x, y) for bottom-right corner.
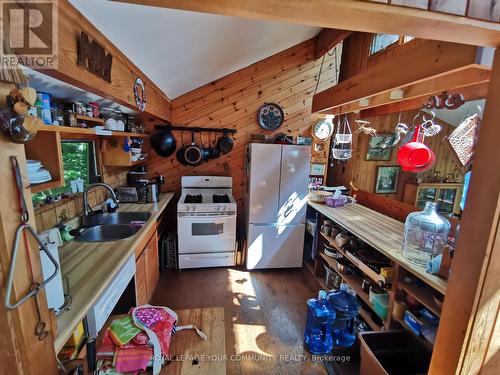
(70, 0), (320, 99)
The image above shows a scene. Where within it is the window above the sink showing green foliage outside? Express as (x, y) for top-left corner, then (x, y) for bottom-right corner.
(33, 140), (100, 201)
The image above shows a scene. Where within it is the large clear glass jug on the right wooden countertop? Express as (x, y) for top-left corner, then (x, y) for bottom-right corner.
(401, 202), (451, 267)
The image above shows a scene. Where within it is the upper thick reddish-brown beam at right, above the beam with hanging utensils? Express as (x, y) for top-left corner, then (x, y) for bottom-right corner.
(312, 41), (481, 113)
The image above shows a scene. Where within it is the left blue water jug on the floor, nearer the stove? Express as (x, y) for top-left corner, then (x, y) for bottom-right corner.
(304, 290), (335, 354)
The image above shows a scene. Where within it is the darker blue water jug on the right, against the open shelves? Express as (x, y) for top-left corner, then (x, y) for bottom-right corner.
(328, 284), (360, 347)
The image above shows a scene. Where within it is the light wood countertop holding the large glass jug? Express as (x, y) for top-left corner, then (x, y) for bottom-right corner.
(308, 202), (447, 294)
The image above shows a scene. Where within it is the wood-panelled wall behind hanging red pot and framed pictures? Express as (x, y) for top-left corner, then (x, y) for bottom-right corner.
(352, 110), (465, 201)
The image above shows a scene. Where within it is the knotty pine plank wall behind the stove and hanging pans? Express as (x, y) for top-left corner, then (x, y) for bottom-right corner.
(149, 39), (340, 210)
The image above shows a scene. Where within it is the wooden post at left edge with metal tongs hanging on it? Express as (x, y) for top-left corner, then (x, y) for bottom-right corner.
(0, 134), (57, 375)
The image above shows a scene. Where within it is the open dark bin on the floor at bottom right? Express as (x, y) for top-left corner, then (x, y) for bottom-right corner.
(359, 330), (432, 375)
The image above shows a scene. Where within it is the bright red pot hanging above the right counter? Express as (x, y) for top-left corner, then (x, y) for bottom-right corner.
(398, 126), (436, 173)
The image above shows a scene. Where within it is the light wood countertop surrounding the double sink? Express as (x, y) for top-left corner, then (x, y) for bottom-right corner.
(54, 192), (174, 353)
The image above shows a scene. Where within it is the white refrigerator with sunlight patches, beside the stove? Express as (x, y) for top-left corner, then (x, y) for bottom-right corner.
(245, 143), (311, 270)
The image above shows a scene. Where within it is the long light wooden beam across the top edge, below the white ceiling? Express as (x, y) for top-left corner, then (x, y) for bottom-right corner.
(111, 0), (500, 47)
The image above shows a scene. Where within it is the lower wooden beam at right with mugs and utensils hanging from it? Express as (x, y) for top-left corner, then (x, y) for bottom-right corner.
(326, 67), (490, 115)
